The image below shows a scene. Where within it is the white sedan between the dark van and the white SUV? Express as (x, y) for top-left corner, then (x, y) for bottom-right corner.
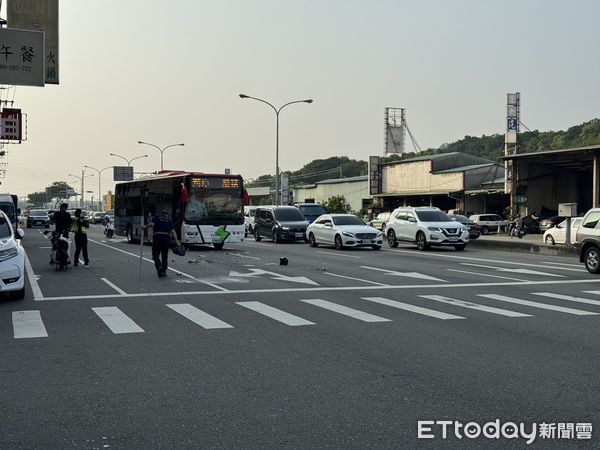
(306, 214), (383, 250)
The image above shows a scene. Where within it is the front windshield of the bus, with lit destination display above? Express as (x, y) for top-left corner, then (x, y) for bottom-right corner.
(185, 177), (244, 225)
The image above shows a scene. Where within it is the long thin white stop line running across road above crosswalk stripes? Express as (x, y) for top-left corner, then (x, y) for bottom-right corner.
(31, 278), (600, 301)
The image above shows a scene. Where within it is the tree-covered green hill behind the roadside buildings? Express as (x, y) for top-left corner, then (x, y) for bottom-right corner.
(247, 119), (600, 187)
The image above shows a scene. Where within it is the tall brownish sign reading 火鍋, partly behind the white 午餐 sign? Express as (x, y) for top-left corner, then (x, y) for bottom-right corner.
(6, 0), (58, 84)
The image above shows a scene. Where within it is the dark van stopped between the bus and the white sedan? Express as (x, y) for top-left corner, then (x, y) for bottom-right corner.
(254, 206), (308, 242)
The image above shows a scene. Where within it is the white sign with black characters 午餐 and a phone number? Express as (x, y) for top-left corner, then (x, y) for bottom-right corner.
(0, 28), (44, 86)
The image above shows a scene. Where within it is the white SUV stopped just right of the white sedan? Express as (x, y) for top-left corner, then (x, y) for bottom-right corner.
(386, 207), (469, 251)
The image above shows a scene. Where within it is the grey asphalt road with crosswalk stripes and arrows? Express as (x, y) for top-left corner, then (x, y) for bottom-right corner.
(0, 225), (600, 449)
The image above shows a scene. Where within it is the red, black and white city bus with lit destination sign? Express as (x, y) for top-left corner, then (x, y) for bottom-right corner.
(114, 171), (247, 249)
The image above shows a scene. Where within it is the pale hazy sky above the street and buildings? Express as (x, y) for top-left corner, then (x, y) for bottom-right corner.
(0, 0), (600, 199)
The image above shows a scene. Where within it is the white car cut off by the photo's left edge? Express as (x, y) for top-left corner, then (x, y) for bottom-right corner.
(0, 211), (25, 300)
